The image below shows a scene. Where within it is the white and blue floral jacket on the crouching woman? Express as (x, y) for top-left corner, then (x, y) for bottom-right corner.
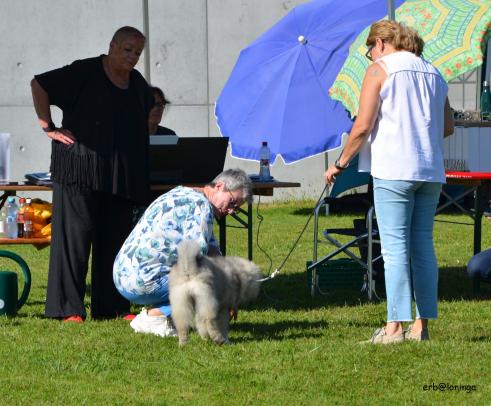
(113, 186), (216, 295)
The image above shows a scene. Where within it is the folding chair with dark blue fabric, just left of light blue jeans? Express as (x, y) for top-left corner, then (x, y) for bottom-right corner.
(307, 156), (383, 300)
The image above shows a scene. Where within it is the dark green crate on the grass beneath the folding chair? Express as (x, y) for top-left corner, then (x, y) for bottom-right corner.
(307, 258), (365, 293)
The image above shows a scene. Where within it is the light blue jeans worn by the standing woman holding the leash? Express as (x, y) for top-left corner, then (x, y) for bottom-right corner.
(373, 179), (442, 322)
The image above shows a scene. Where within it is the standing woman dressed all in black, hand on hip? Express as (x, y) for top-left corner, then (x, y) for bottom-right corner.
(31, 27), (153, 322)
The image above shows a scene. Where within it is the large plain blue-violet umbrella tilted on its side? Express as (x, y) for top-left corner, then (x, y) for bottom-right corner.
(215, 0), (402, 163)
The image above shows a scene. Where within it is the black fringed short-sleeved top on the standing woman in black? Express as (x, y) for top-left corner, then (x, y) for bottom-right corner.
(35, 55), (153, 202)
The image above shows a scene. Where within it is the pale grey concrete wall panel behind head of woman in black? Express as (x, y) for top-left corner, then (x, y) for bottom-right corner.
(0, 0), (143, 106)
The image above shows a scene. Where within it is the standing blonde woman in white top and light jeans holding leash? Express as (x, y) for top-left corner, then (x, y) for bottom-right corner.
(325, 20), (453, 344)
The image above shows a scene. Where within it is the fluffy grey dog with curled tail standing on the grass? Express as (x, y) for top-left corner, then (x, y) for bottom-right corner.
(169, 240), (261, 346)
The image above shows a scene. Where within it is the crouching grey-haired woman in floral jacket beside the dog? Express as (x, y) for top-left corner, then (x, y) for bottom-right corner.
(113, 169), (252, 337)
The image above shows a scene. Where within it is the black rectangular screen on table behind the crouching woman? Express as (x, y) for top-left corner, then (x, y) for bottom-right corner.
(149, 136), (228, 185)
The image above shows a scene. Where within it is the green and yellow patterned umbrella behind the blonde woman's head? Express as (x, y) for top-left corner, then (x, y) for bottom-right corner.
(329, 0), (491, 117)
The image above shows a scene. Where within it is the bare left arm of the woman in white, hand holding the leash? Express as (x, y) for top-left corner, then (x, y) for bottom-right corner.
(324, 63), (387, 185)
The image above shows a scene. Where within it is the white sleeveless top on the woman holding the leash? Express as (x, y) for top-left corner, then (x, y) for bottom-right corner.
(358, 51), (448, 183)
